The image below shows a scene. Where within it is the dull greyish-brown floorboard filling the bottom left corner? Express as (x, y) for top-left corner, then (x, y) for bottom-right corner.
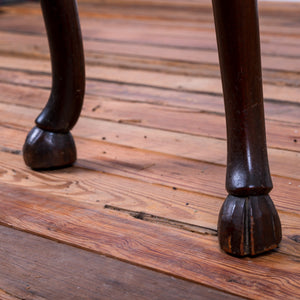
(0, 226), (241, 300)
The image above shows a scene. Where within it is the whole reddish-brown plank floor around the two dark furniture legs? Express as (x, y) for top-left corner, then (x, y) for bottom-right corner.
(0, 0), (300, 300)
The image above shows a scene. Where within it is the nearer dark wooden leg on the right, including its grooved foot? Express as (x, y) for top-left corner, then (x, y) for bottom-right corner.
(213, 0), (281, 256)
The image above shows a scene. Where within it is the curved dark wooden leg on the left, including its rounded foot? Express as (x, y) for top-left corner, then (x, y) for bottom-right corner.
(23, 0), (85, 169)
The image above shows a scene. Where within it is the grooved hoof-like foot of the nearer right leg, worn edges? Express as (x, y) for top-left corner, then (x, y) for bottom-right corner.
(218, 195), (282, 256)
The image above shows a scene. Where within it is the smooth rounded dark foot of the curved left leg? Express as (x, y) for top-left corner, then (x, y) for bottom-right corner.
(23, 127), (76, 170)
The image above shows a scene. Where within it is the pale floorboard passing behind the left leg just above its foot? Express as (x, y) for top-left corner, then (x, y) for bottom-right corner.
(0, 104), (300, 184)
